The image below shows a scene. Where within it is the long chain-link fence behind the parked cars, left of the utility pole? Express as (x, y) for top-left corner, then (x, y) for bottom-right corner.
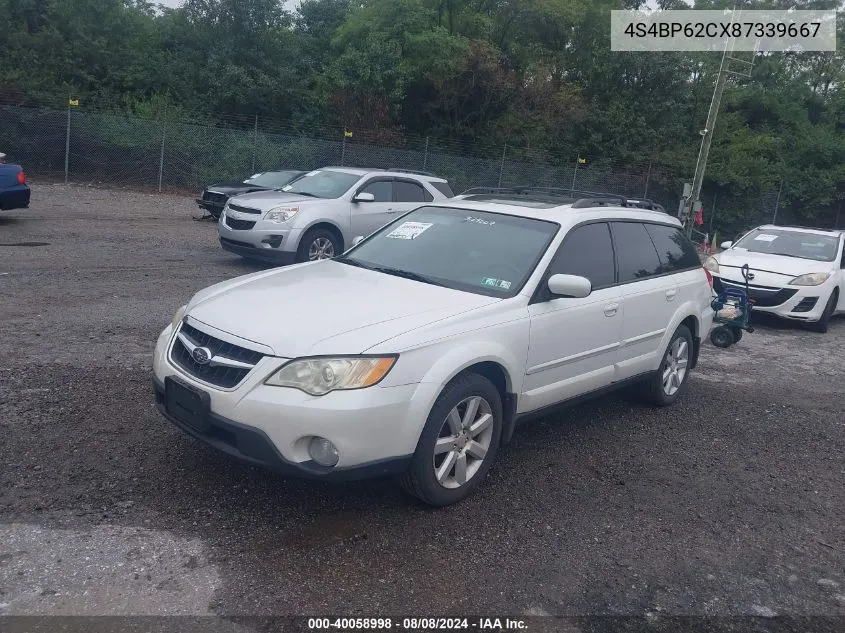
(0, 105), (677, 209)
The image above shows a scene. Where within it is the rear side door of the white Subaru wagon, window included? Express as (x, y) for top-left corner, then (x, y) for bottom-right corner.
(610, 220), (679, 379)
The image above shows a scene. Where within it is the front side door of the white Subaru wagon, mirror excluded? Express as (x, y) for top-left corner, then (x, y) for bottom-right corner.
(520, 222), (622, 412)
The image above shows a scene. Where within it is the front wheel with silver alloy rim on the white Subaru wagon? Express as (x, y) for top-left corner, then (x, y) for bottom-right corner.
(399, 373), (502, 507)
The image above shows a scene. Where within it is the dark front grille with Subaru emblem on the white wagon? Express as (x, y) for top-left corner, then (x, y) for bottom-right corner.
(170, 323), (264, 389)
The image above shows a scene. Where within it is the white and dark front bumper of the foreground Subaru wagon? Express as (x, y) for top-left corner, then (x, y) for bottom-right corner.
(153, 327), (426, 479)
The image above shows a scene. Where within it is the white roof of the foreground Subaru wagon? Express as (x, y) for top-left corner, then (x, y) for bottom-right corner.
(429, 196), (683, 227)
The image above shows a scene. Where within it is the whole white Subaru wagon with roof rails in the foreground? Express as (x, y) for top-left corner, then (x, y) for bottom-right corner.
(153, 190), (713, 506)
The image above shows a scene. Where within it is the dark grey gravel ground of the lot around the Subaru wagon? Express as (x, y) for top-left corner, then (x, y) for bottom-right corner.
(0, 184), (845, 630)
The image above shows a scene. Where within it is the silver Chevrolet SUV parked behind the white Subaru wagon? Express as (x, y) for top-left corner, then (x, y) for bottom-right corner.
(217, 167), (454, 264)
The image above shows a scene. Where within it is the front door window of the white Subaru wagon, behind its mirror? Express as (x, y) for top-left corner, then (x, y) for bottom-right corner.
(549, 222), (615, 290)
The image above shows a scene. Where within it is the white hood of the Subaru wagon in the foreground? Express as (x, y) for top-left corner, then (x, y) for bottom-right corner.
(187, 260), (501, 358)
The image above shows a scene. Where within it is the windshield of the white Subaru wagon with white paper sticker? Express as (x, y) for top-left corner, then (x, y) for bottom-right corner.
(335, 207), (560, 298)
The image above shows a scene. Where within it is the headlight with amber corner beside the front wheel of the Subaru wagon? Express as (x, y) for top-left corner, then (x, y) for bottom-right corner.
(265, 356), (397, 396)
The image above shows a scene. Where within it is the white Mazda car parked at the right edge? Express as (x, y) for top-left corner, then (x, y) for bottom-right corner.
(704, 224), (845, 332)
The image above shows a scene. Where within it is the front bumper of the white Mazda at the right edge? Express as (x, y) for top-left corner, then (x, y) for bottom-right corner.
(713, 275), (832, 321)
